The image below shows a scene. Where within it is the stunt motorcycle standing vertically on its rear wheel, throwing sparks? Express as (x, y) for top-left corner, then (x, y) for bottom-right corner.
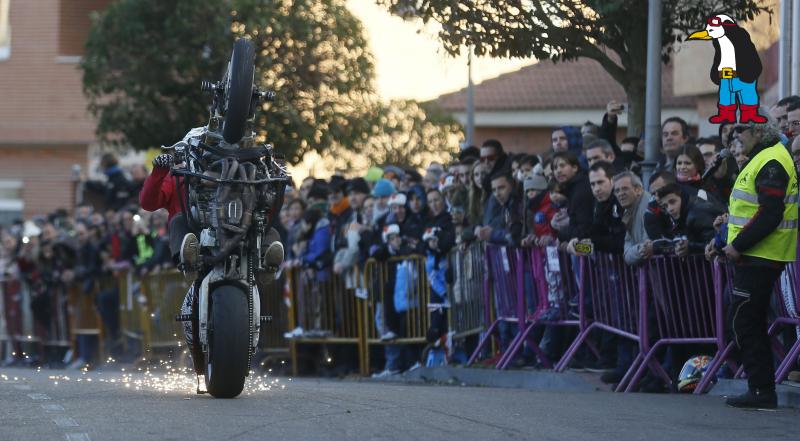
(172, 39), (289, 398)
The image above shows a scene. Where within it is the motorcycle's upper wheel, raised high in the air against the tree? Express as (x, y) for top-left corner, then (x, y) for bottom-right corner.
(222, 38), (255, 144)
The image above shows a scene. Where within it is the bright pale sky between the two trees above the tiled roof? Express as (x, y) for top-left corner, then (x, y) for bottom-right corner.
(347, 0), (533, 101)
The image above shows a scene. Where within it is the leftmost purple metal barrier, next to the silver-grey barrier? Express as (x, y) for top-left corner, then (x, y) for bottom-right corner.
(467, 245), (525, 367)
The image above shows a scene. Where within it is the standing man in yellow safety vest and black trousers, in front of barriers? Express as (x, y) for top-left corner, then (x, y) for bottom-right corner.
(723, 117), (798, 408)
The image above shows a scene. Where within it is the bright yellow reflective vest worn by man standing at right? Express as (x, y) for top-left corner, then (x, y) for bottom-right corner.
(728, 143), (798, 262)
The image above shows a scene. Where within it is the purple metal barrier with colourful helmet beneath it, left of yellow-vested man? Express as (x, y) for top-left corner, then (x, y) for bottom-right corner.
(625, 255), (725, 392)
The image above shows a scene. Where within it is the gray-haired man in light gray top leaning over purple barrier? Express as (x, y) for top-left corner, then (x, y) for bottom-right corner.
(614, 172), (653, 265)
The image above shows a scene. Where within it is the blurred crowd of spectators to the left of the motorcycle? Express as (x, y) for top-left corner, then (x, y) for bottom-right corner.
(0, 154), (174, 368)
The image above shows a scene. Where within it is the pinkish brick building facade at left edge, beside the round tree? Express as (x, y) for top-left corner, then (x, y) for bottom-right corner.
(0, 0), (111, 223)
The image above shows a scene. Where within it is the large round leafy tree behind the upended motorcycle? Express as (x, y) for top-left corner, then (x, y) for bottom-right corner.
(81, 0), (374, 161)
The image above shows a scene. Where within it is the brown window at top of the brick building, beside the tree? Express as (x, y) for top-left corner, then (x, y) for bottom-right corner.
(59, 0), (112, 60)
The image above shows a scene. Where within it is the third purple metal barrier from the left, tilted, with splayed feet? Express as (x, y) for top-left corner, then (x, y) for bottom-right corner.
(555, 253), (642, 391)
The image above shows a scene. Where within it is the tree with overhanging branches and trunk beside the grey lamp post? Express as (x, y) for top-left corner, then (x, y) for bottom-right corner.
(377, 0), (772, 135)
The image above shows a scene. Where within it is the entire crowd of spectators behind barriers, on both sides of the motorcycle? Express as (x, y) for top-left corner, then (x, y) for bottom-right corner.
(0, 96), (800, 387)
